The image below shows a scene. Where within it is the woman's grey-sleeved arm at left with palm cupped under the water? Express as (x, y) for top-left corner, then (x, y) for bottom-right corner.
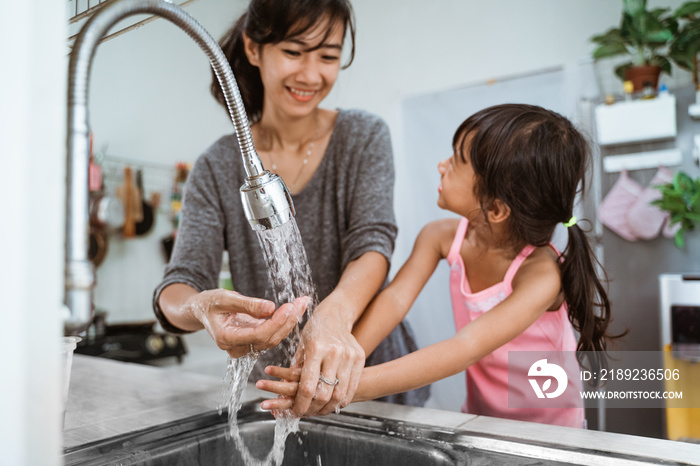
(153, 152), (306, 358)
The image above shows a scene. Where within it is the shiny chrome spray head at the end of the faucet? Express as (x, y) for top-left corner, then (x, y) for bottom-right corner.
(240, 170), (296, 231)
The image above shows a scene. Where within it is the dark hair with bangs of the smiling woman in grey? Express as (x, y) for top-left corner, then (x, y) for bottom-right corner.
(210, 0), (355, 123)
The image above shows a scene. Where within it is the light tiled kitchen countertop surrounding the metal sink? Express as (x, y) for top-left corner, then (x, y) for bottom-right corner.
(64, 354), (700, 464)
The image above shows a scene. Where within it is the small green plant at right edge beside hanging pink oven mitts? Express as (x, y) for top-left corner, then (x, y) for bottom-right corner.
(652, 171), (700, 249)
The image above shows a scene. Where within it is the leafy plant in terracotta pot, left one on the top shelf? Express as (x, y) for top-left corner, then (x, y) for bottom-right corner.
(591, 0), (678, 91)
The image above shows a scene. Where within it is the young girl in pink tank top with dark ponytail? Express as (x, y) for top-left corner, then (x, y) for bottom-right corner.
(257, 104), (610, 427)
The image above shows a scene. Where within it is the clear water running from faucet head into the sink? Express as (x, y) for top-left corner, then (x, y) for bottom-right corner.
(219, 219), (316, 466)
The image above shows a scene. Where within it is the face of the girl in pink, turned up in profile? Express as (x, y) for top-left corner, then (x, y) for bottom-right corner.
(438, 135), (481, 220)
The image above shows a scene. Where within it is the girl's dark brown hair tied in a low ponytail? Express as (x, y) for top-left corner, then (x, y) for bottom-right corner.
(452, 104), (621, 374)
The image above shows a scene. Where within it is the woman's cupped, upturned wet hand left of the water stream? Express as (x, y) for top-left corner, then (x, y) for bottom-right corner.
(185, 289), (309, 358)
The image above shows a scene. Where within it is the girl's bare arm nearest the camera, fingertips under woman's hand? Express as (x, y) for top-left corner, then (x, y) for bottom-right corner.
(257, 248), (561, 409)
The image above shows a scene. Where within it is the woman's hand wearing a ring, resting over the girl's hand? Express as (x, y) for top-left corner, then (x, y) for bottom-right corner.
(293, 301), (365, 416)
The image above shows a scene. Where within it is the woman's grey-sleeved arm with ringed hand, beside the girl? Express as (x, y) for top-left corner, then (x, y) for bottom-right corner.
(294, 111), (397, 416)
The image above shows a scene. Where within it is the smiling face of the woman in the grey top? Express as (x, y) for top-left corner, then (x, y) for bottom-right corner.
(245, 17), (344, 117)
